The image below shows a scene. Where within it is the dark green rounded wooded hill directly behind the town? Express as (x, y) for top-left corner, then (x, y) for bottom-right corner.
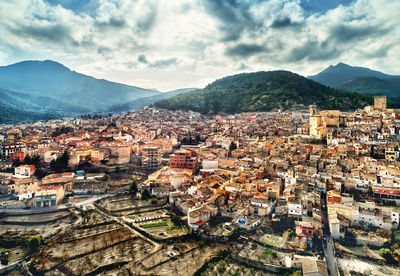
(154, 71), (372, 113)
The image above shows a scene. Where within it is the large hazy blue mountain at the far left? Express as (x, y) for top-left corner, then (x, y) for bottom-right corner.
(0, 60), (160, 111)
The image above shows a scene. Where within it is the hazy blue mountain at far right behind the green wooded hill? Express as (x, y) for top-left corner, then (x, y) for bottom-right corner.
(308, 63), (400, 100)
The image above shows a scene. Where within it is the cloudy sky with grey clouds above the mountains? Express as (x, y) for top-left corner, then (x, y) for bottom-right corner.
(0, 0), (400, 91)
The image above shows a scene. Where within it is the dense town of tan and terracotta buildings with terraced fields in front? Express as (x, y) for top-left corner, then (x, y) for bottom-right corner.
(0, 96), (400, 276)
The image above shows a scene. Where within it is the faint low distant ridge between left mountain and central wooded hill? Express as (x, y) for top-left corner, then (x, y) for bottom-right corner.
(107, 88), (197, 113)
